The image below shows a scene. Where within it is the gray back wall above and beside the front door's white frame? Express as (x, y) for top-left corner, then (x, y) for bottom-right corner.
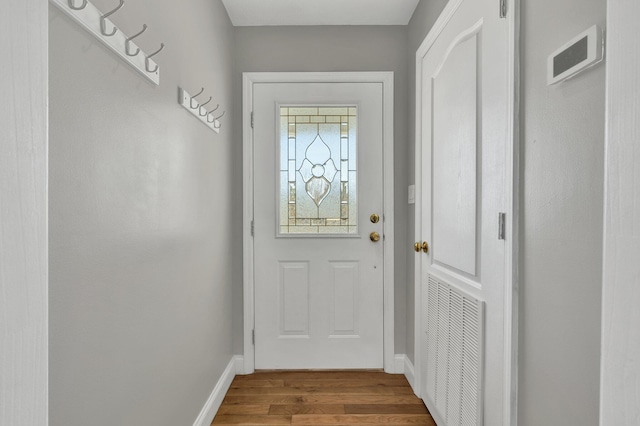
(234, 26), (413, 353)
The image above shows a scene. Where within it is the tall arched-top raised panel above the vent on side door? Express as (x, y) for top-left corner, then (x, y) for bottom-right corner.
(431, 30), (479, 276)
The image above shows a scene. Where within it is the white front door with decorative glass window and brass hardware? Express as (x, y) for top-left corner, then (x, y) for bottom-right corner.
(253, 83), (384, 369)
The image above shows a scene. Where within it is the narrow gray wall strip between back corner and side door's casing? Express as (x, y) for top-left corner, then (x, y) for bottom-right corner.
(405, 0), (448, 363)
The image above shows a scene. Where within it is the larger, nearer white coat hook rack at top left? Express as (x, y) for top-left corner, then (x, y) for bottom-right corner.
(49, 0), (164, 84)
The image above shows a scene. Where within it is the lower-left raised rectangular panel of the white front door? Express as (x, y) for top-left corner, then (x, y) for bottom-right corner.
(278, 262), (309, 337)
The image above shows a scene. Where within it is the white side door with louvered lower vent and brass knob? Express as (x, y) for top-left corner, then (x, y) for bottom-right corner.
(417, 0), (513, 426)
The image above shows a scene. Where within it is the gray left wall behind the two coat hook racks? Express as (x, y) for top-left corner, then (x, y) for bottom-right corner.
(49, 0), (237, 426)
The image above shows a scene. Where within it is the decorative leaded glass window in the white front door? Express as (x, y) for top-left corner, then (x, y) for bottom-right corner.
(279, 106), (358, 235)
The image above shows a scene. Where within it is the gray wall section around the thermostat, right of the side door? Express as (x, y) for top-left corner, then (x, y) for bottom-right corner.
(518, 0), (606, 426)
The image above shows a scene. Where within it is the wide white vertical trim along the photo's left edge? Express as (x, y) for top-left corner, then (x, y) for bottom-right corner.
(0, 1), (50, 426)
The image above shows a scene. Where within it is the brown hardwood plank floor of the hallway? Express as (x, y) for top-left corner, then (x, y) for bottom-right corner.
(212, 370), (435, 426)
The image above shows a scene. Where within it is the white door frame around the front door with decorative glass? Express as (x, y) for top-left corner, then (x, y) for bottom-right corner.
(242, 72), (395, 374)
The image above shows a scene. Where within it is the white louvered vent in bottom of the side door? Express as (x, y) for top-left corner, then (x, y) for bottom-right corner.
(422, 276), (484, 426)
